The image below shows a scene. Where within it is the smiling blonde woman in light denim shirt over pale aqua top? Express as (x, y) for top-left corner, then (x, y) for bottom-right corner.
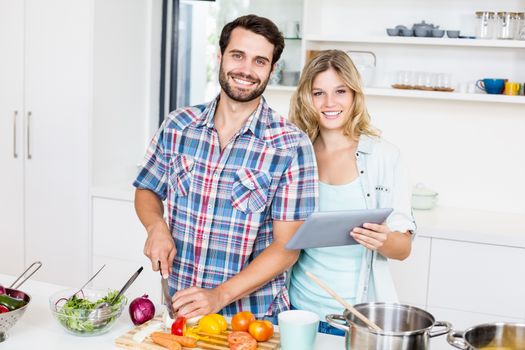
(290, 50), (415, 335)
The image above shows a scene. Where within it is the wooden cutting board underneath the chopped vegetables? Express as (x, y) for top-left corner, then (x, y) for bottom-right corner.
(115, 317), (281, 350)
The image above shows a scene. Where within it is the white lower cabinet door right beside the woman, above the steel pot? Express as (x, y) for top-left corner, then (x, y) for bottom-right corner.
(389, 237), (432, 308)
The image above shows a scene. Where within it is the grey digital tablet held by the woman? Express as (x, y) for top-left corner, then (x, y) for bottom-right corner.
(285, 208), (392, 249)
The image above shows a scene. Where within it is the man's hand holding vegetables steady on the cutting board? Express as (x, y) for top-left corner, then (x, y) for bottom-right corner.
(172, 287), (226, 318)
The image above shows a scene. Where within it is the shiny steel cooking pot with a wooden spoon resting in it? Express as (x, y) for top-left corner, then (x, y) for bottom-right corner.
(326, 303), (452, 350)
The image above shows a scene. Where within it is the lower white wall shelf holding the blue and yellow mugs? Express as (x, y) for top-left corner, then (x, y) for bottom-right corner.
(266, 85), (525, 105)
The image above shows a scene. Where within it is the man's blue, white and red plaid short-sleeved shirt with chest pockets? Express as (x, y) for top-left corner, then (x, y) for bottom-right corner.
(134, 99), (317, 317)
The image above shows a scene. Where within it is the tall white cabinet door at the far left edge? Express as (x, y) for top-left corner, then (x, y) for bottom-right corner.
(0, 0), (24, 275)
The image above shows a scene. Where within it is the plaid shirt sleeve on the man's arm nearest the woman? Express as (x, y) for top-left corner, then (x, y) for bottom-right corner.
(271, 133), (319, 221)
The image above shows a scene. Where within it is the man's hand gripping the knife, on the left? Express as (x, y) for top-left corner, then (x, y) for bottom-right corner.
(144, 221), (177, 278)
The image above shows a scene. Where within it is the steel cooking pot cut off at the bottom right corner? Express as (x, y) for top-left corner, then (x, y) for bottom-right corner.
(447, 322), (525, 350)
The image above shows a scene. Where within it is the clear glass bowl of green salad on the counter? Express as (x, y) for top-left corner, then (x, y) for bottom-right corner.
(49, 288), (128, 337)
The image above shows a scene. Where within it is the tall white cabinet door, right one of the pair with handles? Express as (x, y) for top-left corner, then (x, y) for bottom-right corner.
(25, 0), (93, 285)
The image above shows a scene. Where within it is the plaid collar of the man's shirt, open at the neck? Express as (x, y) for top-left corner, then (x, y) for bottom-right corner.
(196, 96), (271, 140)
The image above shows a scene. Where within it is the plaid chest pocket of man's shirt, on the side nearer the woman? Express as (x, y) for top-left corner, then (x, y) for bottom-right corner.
(231, 168), (270, 213)
